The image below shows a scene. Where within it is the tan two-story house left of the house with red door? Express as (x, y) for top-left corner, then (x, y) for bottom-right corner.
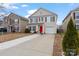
(4, 13), (28, 32)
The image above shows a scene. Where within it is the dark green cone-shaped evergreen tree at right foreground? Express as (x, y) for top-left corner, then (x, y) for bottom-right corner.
(62, 19), (79, 55)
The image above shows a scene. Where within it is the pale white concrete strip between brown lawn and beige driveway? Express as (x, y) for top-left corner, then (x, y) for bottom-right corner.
(0, 34), (39, 50)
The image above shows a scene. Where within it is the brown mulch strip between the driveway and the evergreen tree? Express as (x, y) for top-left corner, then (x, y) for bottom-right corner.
(53, 34), (62, 56)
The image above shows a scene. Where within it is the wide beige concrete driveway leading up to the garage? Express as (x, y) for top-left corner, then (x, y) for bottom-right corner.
(0, 34), (55, 56)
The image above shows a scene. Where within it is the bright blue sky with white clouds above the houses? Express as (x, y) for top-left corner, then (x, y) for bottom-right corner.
(0, 3), (79, 25)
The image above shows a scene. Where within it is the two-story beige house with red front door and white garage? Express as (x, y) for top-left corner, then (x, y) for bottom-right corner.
(28, 8), (57, 33)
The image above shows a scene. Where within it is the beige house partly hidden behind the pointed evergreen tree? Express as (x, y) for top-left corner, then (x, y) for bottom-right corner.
(62, 8), (79, 32)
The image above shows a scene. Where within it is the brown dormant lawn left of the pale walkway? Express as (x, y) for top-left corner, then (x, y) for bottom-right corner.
(0, 33), (31, 43)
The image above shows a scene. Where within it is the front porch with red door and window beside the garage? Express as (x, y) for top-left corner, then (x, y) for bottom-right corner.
(28, 23), (45, 33)
